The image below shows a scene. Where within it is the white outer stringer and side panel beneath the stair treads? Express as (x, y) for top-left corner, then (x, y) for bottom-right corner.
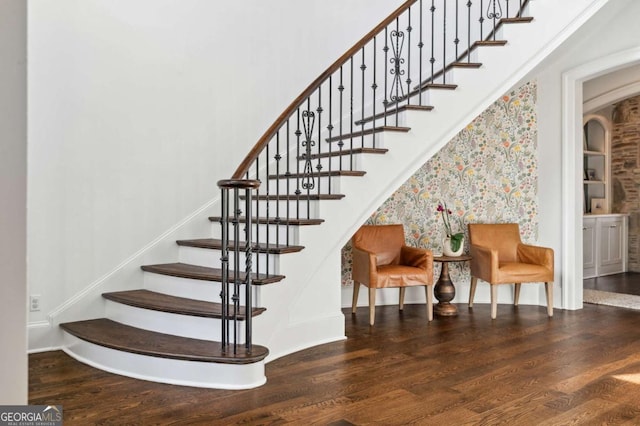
(249, 0), (608, 361)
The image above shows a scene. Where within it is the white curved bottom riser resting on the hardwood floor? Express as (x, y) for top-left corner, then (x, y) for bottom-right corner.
(62, 332), (267, 389)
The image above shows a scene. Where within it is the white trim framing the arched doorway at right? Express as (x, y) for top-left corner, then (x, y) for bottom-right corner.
(562, 47), (640, 310)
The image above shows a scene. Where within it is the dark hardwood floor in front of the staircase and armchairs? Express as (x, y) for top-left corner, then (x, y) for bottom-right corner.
(29, 304), (640, 425)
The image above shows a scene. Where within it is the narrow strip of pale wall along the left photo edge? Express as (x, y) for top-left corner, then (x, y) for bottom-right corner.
(0, 0), (28, 405)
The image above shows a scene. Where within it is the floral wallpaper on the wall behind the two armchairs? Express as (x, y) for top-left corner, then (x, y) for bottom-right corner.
(342, 82), (538, 285)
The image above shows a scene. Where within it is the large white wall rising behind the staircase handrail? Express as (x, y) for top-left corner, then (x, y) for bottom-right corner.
(28, 0), (402, 336)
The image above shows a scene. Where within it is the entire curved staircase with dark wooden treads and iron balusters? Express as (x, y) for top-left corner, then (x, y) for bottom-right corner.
(60, 0), (608, 389)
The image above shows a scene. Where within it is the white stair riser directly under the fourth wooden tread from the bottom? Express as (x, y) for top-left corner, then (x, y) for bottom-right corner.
(178, 246), (280, 274)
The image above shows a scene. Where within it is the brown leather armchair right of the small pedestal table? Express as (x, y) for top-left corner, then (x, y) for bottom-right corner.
(469, 223), (553, 319)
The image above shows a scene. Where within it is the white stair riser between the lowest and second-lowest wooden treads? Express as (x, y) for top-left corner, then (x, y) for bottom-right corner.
(106, 300), (245, 343)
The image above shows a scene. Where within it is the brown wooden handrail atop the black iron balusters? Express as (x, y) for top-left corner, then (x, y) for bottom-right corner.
(232, 0), (418, 179)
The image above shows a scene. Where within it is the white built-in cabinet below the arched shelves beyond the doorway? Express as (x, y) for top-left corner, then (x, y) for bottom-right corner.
(582, 214), (627, 278)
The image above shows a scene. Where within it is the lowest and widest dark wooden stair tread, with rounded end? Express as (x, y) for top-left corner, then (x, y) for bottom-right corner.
(60, 318), (269, 364)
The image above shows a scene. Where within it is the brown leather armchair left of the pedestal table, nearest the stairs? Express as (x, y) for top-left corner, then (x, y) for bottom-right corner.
(351, 225), (433, 325)
